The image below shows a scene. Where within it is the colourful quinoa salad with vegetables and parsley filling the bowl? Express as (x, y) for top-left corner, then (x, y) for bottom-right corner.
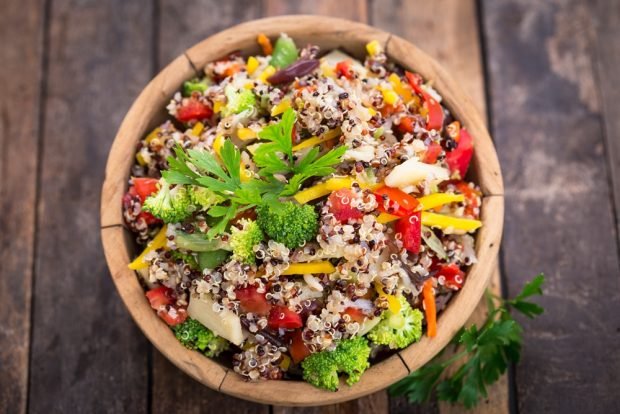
(123, 34), (481, 391)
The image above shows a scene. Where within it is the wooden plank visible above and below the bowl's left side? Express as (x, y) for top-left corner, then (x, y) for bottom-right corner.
(151, 0), (269, 414)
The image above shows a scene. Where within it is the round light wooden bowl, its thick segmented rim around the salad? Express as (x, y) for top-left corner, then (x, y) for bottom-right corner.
(101, 16), (504, 406)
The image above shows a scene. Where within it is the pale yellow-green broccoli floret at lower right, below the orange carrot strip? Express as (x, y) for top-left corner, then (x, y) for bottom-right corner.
(367, 296), (423, 349)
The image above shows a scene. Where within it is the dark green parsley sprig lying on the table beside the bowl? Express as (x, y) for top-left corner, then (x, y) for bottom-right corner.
(390, 274), (545, 408)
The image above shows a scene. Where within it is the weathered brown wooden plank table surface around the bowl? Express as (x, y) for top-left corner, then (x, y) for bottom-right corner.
(0, 0), (620, 414)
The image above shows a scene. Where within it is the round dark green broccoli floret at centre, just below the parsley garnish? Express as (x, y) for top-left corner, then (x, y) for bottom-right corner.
(257, 201), (319, 249)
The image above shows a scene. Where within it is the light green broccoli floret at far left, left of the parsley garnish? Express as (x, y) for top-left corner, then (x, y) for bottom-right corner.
(142, 178), (195, 223)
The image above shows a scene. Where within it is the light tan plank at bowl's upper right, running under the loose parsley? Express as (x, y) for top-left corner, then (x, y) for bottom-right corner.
(370, 0), (508, 413)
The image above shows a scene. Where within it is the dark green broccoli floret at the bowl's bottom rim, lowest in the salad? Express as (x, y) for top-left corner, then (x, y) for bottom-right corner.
(301, 336), (370, 391)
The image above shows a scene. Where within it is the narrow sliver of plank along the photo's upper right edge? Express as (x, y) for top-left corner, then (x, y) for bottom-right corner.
(594, 0), (620, 241)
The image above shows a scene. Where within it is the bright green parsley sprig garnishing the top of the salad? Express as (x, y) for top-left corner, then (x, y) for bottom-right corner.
(162, 108), (346, 237)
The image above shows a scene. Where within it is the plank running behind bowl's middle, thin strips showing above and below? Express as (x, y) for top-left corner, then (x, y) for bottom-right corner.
(264, 0), (388, 414)
